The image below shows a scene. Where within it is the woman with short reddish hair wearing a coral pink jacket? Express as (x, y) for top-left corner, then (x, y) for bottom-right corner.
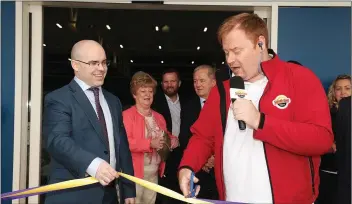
(123, 72), (178, 204)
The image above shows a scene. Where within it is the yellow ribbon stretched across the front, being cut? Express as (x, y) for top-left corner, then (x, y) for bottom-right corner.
(2, 172), (211, 204)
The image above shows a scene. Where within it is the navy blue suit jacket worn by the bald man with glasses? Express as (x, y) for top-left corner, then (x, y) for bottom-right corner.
(43, 80), (136, 204)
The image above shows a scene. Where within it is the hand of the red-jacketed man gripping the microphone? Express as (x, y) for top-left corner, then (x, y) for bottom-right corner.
(232, 98), (260, 130)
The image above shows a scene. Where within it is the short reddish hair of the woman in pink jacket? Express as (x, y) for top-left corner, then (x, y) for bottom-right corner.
(130, 71), (157, 95)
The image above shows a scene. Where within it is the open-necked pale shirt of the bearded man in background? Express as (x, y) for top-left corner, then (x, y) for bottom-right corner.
(165, 94), (181, 137)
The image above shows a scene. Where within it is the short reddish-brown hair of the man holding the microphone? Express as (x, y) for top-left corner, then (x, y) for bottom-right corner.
(218, 13), (269, 47)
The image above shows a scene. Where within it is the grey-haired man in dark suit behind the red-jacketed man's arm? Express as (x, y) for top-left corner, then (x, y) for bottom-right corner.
(179, 65), (218, 200)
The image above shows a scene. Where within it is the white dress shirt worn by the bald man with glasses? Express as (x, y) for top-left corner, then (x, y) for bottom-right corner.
(74, 77), (116, 177)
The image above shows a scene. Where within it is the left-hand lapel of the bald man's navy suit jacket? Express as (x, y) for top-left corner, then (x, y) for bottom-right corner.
(69, 80), (108, 147)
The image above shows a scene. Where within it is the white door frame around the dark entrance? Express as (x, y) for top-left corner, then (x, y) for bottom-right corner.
(13, 0), (351, 203)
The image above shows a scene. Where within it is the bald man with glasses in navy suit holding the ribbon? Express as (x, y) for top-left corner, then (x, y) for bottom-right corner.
(43, 40), (136, 204)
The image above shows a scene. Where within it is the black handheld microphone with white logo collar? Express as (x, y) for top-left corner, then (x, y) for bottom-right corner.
(230, 76), (247, 130)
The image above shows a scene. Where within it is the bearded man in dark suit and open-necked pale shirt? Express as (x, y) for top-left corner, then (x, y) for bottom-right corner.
(152, 69), (182, 204)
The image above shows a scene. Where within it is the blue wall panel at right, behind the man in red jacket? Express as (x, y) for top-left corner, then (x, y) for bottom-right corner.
(278, 8), (351, 88)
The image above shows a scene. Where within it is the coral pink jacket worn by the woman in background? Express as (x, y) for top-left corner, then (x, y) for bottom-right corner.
(122, 106), (175, 178)
